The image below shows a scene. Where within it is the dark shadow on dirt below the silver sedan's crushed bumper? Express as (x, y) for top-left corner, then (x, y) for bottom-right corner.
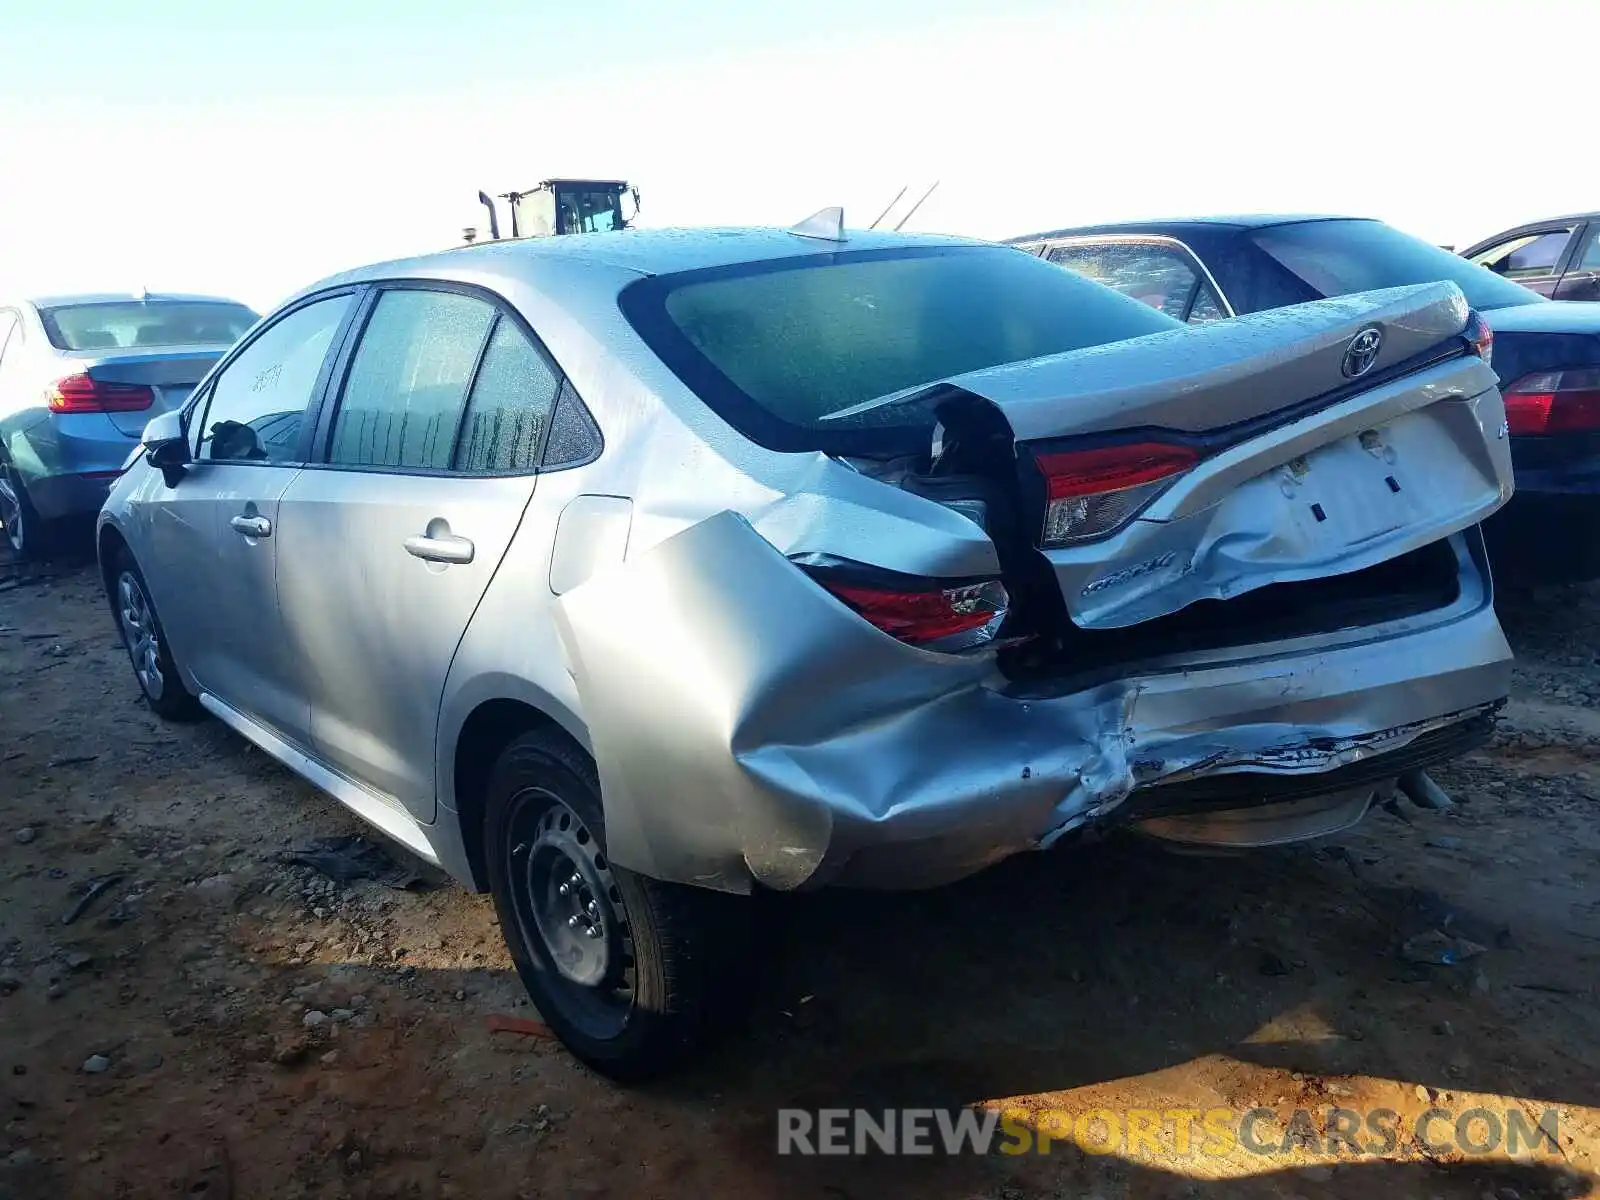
(701, 838), (1600, 1106)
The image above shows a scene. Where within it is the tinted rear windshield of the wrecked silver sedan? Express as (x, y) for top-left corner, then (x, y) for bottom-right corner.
(621, 246), (1182, 454)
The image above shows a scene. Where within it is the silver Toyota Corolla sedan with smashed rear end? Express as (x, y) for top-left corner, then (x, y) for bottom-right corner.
(99, 222), (1512, 1078)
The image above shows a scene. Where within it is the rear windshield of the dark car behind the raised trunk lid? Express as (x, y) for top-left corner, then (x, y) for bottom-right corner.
(1251, 221), (1542, 309)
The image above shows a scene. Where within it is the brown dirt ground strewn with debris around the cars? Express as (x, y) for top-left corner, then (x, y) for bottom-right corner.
(0, 547), (1600, 1200)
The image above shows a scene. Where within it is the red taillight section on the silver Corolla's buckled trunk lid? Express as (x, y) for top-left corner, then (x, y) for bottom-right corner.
(1035, 442), (1200, 549)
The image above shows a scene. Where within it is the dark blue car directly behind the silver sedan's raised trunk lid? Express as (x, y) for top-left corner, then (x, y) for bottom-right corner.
(1008, 216), (1600, 582)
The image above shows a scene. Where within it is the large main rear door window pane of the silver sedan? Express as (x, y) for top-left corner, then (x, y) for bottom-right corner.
(328, 288), (496, 470)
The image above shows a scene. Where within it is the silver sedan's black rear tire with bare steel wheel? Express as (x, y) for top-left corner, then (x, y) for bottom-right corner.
(483, 731), (752, 1082)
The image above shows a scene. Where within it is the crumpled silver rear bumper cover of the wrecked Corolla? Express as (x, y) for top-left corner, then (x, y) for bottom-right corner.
(558, 512), (1510, 891)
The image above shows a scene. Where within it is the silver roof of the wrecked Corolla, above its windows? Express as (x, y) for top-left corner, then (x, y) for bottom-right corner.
(307, 229), (986, 291)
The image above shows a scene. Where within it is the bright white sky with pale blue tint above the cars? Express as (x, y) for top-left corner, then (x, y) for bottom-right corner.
(0, 0), (1600, 307)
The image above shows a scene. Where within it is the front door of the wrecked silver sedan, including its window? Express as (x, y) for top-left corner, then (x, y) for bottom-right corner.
(178, 294), (354, 746)
